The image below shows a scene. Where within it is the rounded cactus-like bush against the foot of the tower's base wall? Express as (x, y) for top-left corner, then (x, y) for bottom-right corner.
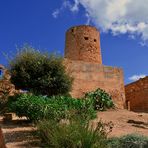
(85, 89), (114, 111)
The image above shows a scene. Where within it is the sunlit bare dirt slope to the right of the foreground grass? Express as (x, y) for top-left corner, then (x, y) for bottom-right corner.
(94, 110), (148, 137)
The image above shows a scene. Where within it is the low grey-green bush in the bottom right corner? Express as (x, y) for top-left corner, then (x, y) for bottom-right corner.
(108, 134), (148, 148)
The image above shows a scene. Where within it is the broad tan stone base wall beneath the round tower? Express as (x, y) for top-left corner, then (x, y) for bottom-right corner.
(65, 59), (125, 108)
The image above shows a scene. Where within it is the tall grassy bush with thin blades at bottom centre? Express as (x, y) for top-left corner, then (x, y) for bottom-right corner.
(37, 120), (107, 148)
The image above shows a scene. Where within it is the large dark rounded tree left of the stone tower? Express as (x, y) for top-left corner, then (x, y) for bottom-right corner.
(9, 45), (72, 96)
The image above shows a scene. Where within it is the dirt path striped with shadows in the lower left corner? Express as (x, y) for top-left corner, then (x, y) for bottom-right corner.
(0, 117), (39, 148)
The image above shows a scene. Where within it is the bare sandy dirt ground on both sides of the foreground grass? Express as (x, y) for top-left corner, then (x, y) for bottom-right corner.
(0, 110), (148, 148)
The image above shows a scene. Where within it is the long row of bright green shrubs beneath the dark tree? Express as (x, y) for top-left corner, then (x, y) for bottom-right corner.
(8, 94), (96, 121)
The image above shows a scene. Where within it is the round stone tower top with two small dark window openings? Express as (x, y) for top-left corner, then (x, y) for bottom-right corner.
(65, 25), (102, 64)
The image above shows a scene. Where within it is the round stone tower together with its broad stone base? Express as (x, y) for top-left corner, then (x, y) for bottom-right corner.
(65, 25), (125, 108)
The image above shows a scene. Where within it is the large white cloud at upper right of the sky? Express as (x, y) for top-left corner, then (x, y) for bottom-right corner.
(53, 0), (148, 43)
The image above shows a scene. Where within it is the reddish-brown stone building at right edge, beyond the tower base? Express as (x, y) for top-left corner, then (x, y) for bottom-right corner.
(125, 76), (148, 112)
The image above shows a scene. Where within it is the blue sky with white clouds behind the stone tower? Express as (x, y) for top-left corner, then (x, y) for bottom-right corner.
(0, 0), (148, 83)
